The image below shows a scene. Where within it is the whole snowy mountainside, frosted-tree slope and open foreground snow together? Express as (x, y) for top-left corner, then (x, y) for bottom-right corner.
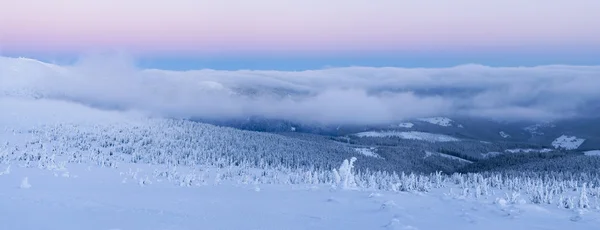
(0, 98), (600, 230)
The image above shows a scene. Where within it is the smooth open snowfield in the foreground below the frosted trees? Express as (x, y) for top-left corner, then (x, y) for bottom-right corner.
(0, 164), (600, 230)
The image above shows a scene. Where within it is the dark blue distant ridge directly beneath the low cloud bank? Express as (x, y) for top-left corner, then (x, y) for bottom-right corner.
(203, 117), (600, 153)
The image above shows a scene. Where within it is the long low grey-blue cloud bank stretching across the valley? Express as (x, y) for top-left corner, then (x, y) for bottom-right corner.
(0, 55), (600, 124)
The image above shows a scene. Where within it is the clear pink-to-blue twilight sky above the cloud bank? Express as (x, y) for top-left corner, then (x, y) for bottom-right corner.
(0, 0), (600, 70)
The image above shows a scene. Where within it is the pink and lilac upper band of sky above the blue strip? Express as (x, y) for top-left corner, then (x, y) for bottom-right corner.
(0, 0), (600, 53)
